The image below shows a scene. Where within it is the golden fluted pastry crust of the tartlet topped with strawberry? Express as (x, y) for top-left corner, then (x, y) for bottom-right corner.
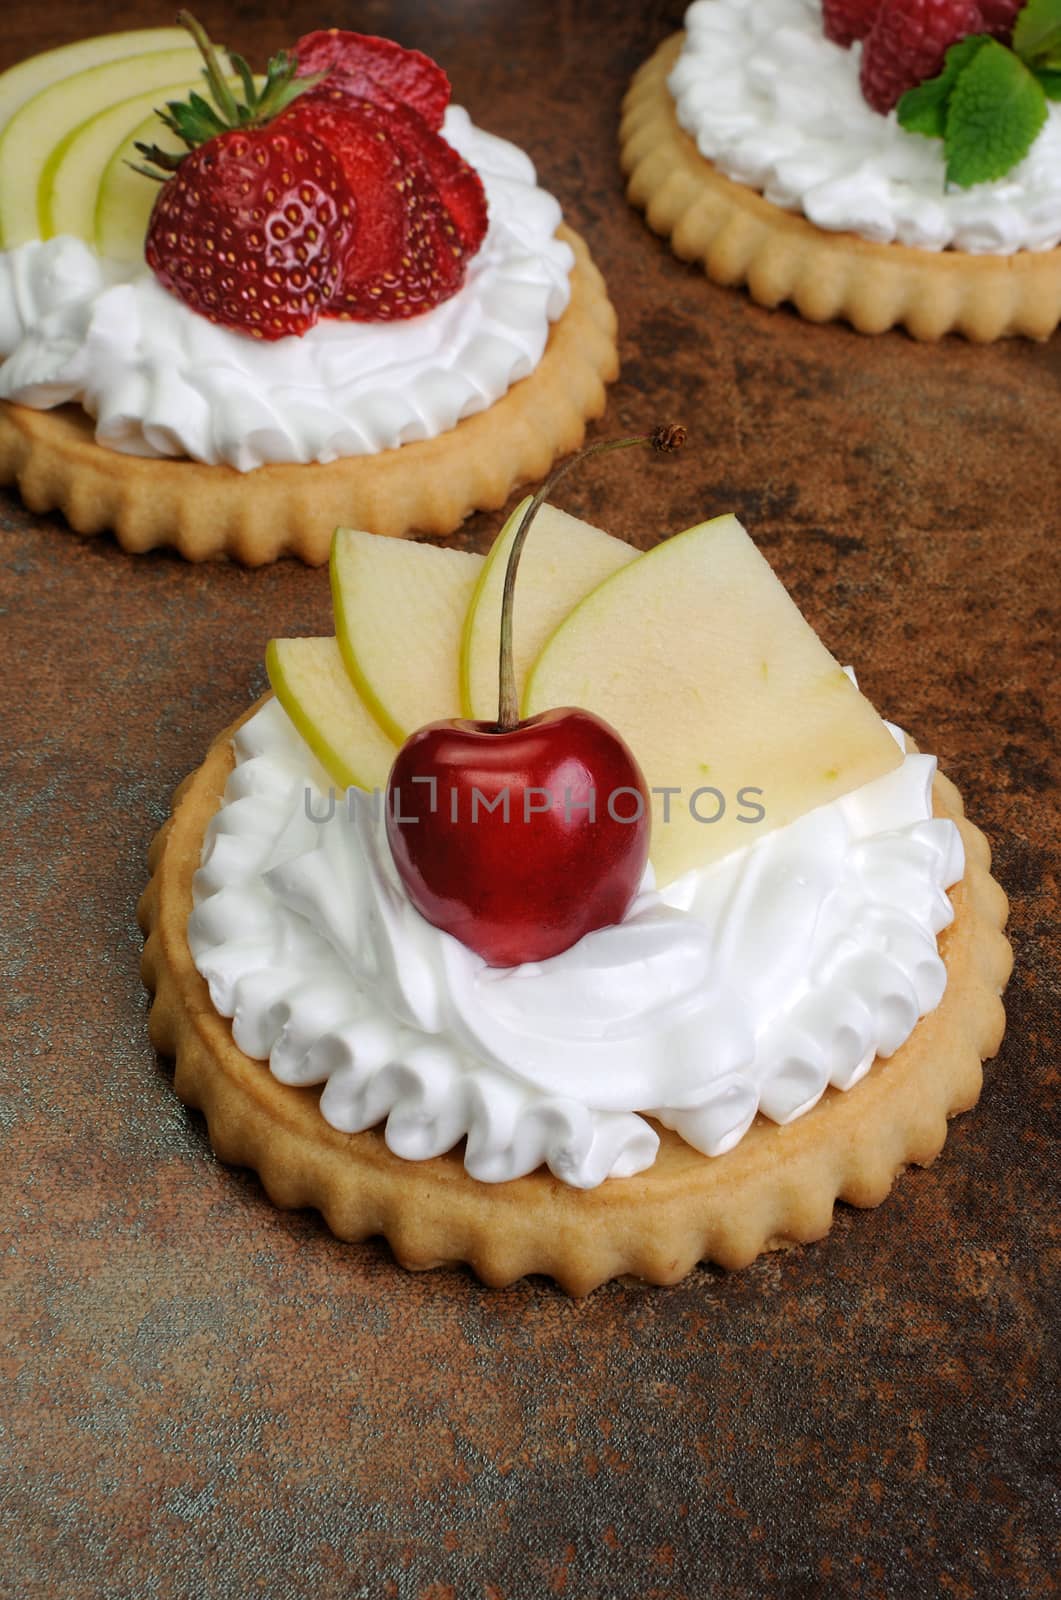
(0, 227), (619, 566)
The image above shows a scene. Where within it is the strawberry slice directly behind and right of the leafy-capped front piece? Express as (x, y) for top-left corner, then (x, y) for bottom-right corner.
(283, 94), (467, 322)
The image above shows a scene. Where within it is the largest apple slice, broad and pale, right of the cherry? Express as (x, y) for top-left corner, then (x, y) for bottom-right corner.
(523, 517), (903, 883)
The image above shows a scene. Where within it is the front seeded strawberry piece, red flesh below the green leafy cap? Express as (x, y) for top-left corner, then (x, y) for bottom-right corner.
(144, 129), (357, 339)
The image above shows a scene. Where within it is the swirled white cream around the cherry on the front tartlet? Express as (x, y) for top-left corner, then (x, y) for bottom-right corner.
(189, 701), (963, 1189)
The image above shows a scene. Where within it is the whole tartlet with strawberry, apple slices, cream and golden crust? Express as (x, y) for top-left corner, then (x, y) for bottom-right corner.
(0, 13), (618, 565)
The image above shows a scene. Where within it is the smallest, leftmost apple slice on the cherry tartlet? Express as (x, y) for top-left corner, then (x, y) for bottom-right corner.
(266, 638), (398, 790)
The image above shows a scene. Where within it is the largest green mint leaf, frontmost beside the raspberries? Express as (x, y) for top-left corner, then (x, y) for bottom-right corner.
(943, 38), (1047, 189)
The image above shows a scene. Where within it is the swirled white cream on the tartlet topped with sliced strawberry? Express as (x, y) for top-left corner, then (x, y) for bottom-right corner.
(0, 106), (575, 472)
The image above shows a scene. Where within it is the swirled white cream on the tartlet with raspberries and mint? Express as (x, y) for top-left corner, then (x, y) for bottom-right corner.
(667, 0), (1061, 254)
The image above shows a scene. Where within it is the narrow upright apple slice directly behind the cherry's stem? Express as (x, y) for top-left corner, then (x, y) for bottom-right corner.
(461, 496), (640, 722)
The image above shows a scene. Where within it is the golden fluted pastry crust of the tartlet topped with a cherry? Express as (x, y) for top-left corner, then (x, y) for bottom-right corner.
(139, 702), (1011, 1294)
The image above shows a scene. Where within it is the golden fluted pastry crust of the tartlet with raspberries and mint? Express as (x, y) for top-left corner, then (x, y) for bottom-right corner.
(619, 34), (1061, 344)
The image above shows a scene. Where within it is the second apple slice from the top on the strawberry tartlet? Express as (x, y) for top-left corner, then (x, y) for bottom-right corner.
(0, 45), (198, 250)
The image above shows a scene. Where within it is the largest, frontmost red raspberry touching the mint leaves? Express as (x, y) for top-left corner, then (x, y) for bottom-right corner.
(861, 0), (984, 114)
